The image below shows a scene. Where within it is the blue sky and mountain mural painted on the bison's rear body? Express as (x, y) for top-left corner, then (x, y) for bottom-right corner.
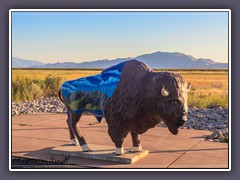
(61, 62), (125, 121)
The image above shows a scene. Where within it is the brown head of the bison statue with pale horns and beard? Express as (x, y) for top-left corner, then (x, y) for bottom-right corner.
(154, 72), (190, 135)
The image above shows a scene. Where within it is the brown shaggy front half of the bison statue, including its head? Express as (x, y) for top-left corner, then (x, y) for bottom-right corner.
(104, 60), (190, 148)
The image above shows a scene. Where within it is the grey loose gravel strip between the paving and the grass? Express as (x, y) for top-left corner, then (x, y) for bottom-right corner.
(12, 97), (228, 142)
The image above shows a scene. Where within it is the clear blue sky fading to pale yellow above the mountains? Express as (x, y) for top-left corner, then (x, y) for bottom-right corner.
(12, 12), (228, 63)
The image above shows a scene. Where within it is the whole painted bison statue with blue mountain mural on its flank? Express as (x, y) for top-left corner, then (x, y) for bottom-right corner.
(59, 60), (190, 155)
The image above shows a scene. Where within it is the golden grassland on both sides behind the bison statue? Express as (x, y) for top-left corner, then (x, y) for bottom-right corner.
(12, 69), (228, 108)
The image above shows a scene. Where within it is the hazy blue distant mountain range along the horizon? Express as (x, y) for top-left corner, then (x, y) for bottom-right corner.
(12, 51), (228, 69)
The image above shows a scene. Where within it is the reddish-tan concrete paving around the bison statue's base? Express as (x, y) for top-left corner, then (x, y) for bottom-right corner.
(12, 113), (228, 168)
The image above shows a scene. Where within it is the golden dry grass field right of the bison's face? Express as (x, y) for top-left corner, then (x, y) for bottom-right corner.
(162, 70), (228, 108)
